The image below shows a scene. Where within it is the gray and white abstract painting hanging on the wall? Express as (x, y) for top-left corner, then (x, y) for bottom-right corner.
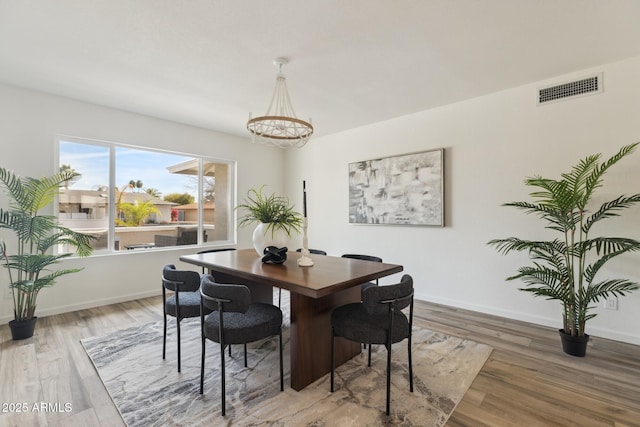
(349, 148), (444, 227)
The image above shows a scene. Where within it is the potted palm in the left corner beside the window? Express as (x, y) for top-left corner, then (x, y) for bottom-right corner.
(0, 168), (93, 340)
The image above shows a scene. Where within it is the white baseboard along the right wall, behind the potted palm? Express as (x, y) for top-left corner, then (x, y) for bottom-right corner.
(415, 294), (640, 345)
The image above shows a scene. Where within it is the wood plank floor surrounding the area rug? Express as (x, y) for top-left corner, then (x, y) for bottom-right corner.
(0, 297), (640, 427)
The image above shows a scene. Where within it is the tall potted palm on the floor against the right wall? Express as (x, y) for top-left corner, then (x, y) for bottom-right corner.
(489, 143), (640, 356)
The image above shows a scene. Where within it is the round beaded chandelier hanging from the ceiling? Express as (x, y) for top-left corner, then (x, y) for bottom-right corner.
(247, 58), (313, 148)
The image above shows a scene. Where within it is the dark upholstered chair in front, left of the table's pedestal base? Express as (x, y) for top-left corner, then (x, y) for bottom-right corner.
(200, 275), (284, 416)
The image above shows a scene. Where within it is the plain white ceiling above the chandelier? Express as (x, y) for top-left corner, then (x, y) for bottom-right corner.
(0, 0), (640, 136)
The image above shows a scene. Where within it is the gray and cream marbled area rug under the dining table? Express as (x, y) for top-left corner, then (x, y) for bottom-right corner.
(82, 302), (492, 427)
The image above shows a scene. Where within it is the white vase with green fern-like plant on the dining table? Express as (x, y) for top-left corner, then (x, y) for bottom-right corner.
(236, 185), (302, 257)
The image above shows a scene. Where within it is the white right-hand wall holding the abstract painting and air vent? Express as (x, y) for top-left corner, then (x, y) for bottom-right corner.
(286, 57), (640, 344)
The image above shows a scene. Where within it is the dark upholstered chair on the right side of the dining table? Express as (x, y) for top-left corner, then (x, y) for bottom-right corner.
(331, 274), (413, 415)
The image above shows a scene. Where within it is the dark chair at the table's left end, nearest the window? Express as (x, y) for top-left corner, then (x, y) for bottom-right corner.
(162, 264), (210, 372)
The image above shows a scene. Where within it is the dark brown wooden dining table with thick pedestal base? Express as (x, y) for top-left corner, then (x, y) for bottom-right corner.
(180, 249), (403, 390)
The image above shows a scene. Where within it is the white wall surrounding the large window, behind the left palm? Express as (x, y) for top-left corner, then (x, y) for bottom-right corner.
(0, 85), (284, 322)
